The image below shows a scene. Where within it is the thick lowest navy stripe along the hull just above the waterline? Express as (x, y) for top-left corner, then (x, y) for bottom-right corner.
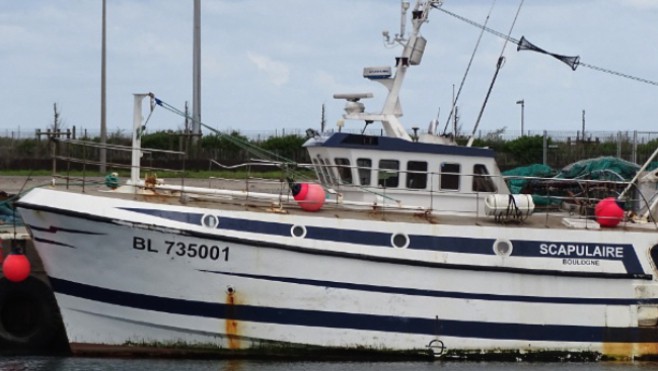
(50, 277), (658, 343)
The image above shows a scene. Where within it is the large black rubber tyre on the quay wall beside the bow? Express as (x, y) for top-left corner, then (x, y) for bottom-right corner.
(0, 276), (63, 349)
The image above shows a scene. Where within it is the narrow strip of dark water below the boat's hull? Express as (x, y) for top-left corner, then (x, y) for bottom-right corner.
(0, 357), (658, 371)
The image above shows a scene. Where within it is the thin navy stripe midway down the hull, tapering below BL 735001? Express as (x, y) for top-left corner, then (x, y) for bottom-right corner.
(202, 270), (658, 305)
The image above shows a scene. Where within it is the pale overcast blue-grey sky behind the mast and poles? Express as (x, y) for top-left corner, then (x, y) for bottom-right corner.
(0, 0), (658, 140)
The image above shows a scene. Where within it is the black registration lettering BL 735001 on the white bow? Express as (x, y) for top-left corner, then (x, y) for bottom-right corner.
(133, 237), (230, 261)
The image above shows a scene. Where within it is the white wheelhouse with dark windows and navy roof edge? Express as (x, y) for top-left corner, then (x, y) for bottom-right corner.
(305, 133), (502, 213)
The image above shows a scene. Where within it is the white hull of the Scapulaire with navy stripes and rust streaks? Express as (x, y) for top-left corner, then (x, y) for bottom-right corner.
(15, 189), (658, 357)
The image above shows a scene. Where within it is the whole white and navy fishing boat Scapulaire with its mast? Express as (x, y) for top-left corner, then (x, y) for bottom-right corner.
(17, 0), (658, 360)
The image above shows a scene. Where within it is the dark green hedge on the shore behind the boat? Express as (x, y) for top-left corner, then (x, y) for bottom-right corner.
(0, 128), (658, 178)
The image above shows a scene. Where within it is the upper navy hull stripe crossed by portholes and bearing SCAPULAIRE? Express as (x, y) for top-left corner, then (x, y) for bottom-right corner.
(122, 208), (645, 275)
